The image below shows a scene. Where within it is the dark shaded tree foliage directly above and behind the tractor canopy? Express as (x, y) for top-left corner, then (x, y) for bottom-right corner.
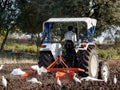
(18, 0), (89, 34)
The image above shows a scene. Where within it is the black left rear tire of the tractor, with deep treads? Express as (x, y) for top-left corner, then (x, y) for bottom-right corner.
(38, 51), (54, 68)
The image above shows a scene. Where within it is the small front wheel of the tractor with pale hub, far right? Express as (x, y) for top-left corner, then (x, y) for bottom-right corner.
(98, 61), (110, 81)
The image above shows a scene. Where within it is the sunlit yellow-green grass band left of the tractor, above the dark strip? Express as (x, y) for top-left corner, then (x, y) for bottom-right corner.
(0, 36), (37, 53)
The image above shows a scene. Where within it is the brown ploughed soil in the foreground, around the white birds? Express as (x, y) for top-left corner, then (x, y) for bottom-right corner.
(0, 60), (120, 90)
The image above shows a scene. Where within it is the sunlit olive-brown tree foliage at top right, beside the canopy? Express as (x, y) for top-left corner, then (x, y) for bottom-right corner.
(90, 0), (120, 36)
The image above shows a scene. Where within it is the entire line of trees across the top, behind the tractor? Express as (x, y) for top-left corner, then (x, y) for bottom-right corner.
(0, 0), (120, 51)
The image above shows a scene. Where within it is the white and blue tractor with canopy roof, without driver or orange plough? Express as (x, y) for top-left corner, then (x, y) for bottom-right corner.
(38, 17), (109, 79)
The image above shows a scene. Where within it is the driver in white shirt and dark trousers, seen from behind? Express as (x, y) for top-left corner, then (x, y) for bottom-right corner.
(64, 26), (77, 67)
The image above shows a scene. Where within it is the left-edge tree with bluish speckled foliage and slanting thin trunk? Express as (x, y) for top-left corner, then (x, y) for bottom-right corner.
(0, 0), (19, 51)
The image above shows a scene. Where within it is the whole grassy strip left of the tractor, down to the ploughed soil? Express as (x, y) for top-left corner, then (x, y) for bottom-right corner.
(0, 36), (38, 62)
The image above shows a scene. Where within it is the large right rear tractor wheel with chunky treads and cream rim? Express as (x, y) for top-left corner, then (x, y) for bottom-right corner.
(77, 48), (99, 78)
